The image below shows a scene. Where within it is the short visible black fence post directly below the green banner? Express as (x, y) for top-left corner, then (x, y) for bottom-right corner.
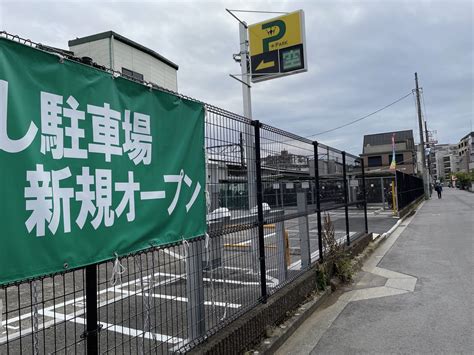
(84, 264), (100, 355)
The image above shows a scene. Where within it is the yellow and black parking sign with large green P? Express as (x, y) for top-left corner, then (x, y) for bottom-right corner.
(248, 10), (307, 83)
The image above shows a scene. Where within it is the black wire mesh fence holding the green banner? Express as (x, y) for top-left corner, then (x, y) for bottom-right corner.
(0, 29), (366, 354)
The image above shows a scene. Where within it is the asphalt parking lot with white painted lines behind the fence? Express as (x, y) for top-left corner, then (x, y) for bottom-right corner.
(0, 208), (397, 354)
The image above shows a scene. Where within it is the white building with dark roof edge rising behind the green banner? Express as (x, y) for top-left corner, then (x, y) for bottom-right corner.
(69, 31), (178, 91)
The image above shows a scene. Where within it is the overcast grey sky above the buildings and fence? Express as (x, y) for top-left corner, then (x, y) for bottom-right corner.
(0, 0), (474, 154)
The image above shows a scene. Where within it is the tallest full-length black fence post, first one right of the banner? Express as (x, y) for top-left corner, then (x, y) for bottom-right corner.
(252, 120), (268, 303)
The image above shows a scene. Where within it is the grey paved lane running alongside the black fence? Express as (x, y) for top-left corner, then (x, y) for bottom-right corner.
(277, 189), (474, 354)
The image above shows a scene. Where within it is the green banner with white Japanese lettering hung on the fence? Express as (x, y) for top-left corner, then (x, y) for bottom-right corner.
(0, 39), (206, 284)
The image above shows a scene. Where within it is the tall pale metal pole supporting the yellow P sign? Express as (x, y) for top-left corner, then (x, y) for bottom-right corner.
(239, 22), (257, 209)
